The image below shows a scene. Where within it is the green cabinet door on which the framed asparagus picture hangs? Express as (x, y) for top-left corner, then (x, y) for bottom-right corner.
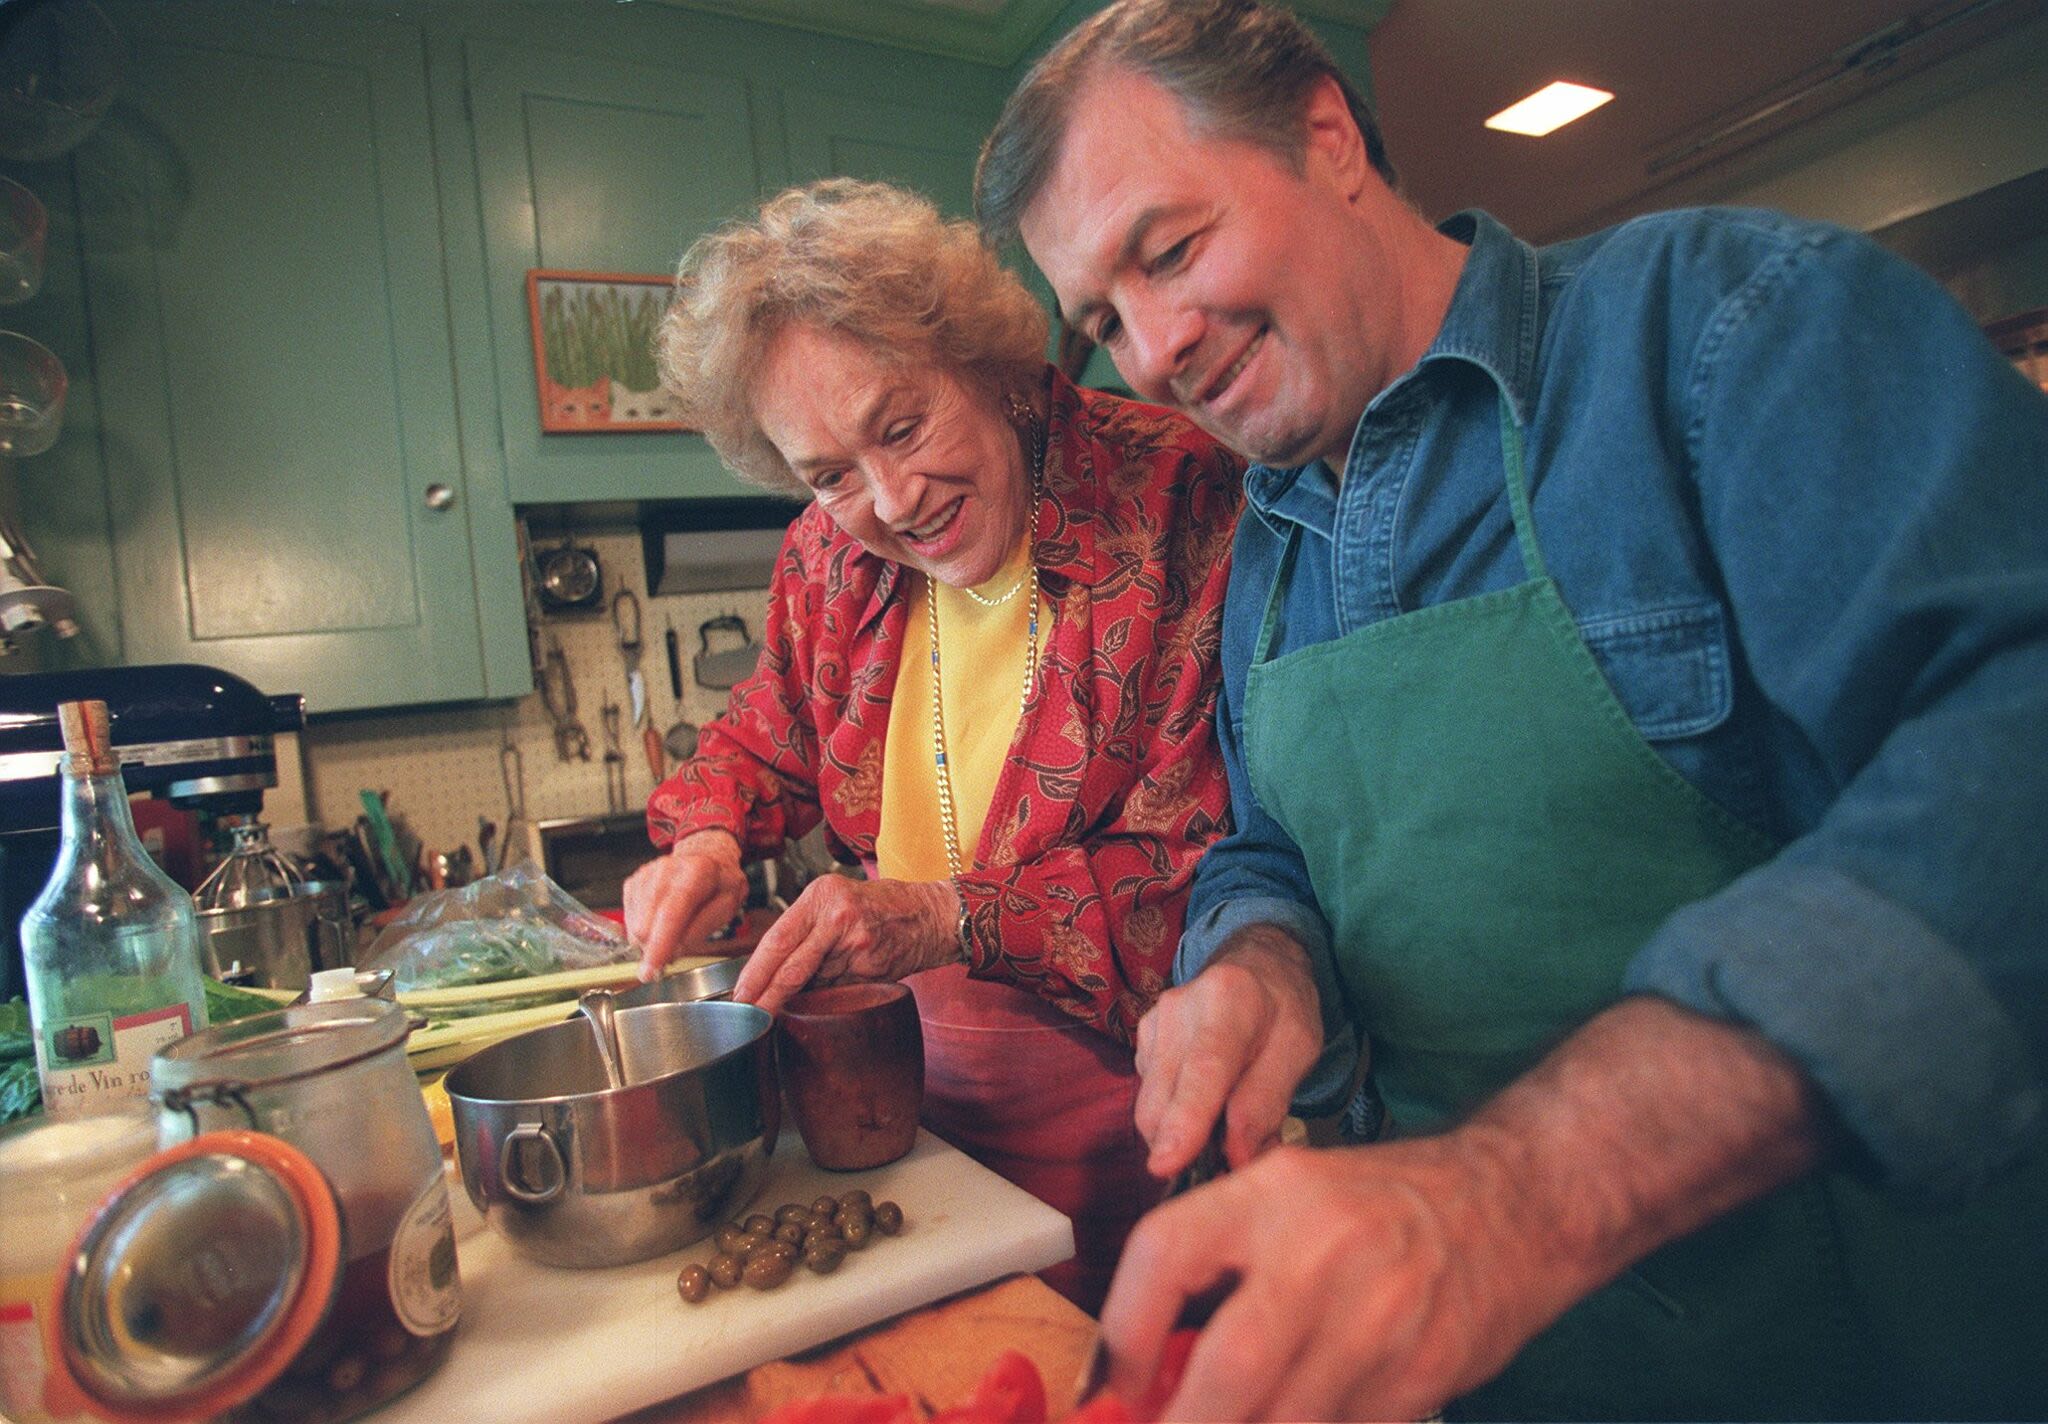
(465, 43), (762, 504)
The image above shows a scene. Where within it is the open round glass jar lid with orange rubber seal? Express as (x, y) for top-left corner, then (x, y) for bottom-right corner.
(49, 1131), (342, 1424)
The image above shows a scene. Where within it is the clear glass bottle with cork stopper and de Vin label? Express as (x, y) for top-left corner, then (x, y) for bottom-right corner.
(20, 703), (207, 1117)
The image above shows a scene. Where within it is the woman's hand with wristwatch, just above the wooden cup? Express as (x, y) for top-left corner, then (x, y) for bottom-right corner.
(733, 875), (963, 1014)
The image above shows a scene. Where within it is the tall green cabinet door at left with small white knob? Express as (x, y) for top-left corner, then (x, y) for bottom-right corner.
(78, 6), (483, 711)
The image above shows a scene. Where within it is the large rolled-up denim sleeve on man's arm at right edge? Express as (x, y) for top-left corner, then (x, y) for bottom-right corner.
(1626, 234), (2048, 1201)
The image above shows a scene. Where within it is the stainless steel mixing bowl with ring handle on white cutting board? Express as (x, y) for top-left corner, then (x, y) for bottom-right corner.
(444, 1002), (780, 1266)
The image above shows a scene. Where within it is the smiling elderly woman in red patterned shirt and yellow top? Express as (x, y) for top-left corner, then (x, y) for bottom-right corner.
(625, 180), (1239, 1309)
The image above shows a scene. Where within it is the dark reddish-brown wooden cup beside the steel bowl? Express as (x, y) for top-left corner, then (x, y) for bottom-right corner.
(774, 983), (924, 1172)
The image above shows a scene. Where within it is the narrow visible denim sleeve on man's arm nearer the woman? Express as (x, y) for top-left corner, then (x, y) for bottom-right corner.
(1174, 528), (1360, 1117)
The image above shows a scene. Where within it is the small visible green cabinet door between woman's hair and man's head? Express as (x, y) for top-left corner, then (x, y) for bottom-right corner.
(782, 90), (995, 217)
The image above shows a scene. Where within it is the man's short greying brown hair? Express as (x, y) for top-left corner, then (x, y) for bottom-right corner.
(975, 0), (1395, 244)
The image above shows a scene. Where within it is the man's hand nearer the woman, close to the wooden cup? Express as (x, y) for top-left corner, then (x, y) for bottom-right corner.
(1135, 924), (1323, 1178)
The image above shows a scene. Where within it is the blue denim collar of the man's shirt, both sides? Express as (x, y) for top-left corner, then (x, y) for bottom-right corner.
(1245, 209), (1542, 535)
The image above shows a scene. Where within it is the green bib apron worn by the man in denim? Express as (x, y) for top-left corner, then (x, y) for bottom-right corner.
(1243, 400), (2048, 1420)
